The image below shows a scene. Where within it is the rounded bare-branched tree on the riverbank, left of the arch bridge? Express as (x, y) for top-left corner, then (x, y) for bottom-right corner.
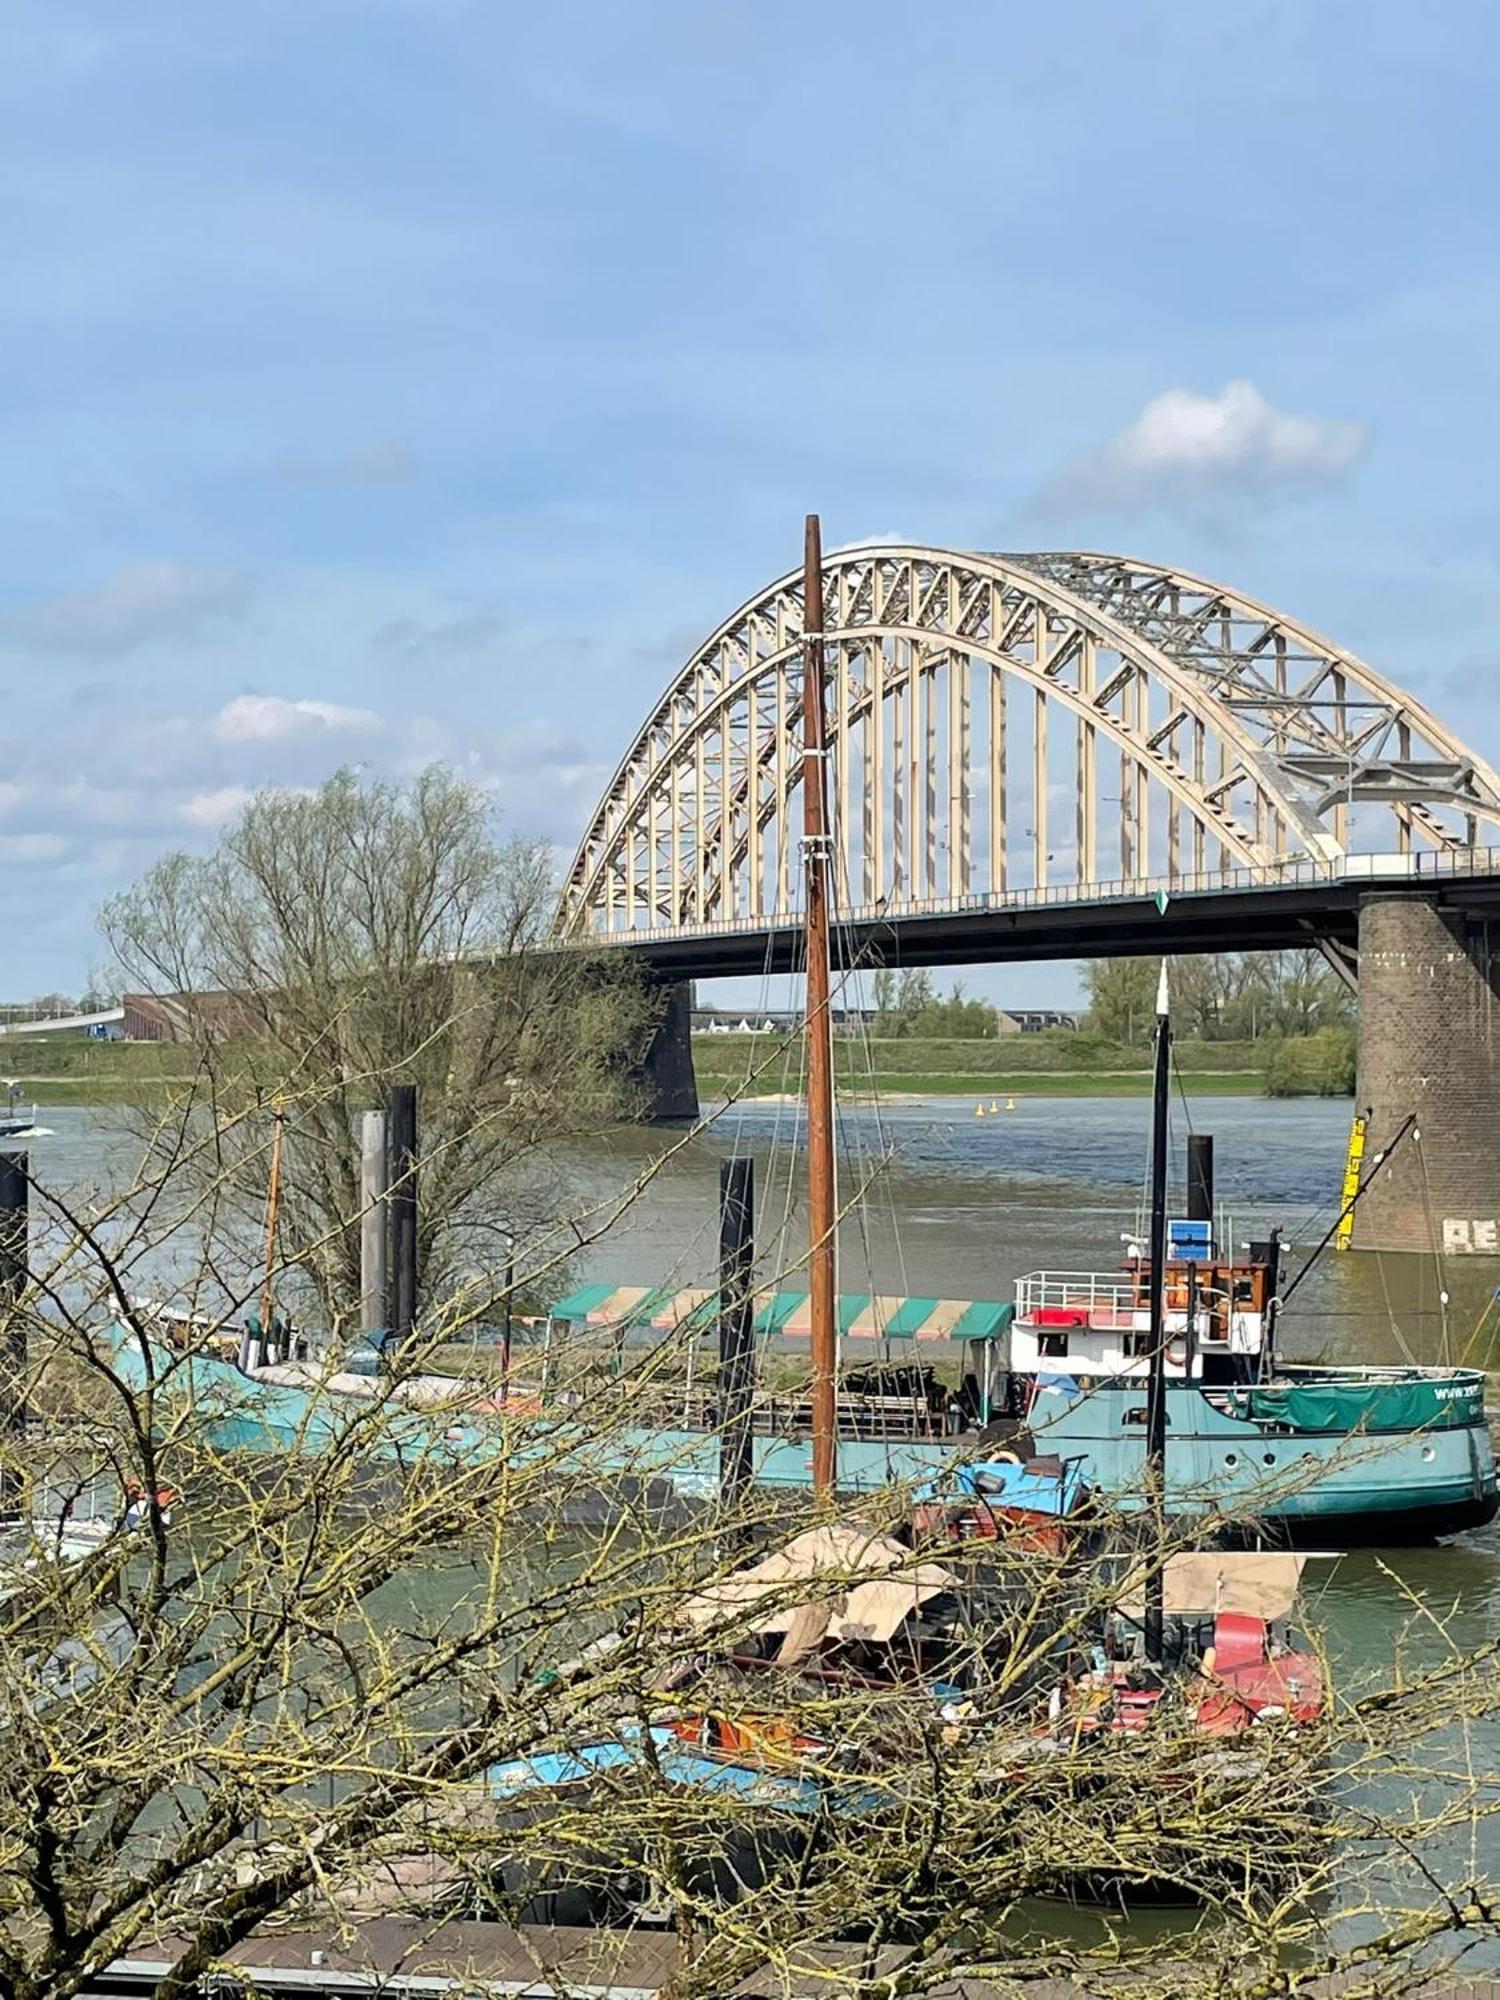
(102, 766), (654, 1324)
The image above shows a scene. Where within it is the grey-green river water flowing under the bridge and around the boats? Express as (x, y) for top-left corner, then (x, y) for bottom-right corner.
(32, 1096), (1500, 1952)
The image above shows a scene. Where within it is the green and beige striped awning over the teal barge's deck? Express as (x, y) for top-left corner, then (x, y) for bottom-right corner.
(552, 1284), (1016, 1340)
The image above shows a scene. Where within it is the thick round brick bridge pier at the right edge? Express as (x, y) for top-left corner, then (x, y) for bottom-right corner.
(1354, 894), (1500, 1256)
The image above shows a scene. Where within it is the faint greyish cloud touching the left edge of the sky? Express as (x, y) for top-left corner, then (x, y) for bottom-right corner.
(4, 562), (250, 658)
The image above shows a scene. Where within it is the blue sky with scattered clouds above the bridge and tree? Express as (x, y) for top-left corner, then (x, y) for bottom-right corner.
(0, 0), (1500, 1004)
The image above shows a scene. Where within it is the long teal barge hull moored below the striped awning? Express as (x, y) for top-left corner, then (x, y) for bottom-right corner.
(116, 1298), (1500, 1546)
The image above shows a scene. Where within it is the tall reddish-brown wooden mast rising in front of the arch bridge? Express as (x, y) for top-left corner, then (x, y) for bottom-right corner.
(802, 514), (838, 1496)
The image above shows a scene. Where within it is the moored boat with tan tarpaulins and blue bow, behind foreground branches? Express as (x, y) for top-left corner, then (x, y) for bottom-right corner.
(408, 1522), (1326, 1924)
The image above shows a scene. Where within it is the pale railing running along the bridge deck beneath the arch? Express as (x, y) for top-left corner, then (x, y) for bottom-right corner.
(578, 848), (1500, 944)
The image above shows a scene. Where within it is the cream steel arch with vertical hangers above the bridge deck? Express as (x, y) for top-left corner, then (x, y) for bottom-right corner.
(558, 544), (1500, 972)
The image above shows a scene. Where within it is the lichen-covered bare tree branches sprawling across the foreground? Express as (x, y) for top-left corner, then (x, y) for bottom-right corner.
(0, 1056), (1500, 2000)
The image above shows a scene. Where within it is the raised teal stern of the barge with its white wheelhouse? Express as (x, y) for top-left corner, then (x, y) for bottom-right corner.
(1010, 1242), (1500, 1544)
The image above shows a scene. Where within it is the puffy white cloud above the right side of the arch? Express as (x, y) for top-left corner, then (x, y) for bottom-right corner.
(1040, 380), (1368, 512)
